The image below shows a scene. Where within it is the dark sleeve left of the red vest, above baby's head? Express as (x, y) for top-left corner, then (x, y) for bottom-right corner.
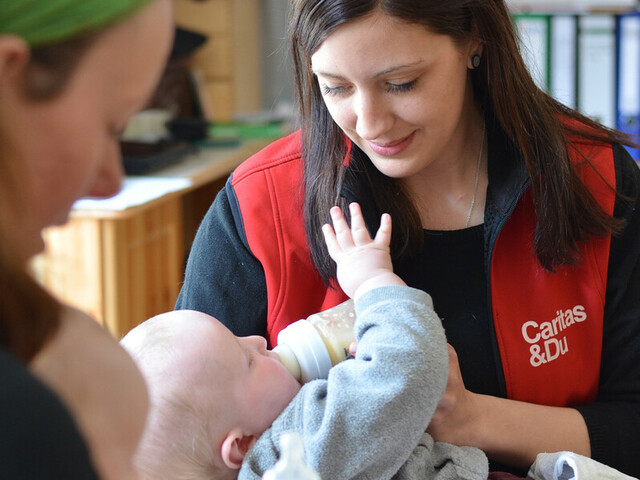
(175, 179), (267, 336)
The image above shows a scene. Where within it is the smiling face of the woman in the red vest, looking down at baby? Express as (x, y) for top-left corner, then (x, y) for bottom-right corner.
(311, 12), (476, 182)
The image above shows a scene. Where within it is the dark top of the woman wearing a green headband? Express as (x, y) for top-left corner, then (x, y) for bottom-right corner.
(0, 349), (98, 480)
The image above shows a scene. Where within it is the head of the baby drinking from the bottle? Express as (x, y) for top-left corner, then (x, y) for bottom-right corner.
(121, 310), (300, 479)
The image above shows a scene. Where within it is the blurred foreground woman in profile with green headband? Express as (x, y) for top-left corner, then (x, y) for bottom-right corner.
(0, 0), (174, 479)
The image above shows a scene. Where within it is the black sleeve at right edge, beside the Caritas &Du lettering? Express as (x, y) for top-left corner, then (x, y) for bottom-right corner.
(578, 147), (640, 477)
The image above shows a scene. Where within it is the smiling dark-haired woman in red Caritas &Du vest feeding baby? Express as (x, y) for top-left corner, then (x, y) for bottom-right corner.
(177, 0), (640, 476)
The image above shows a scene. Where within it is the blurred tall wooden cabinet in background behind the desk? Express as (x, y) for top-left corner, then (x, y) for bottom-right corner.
(175, 0), (262, 121)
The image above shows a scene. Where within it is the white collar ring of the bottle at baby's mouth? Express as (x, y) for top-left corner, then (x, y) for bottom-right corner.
(274, 320), (331, 383)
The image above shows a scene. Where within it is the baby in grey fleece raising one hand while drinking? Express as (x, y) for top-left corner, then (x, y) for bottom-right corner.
(122, 204), (488, 480)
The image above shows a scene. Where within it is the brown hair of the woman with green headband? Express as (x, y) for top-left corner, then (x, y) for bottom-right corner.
(0, 35), (94, 361)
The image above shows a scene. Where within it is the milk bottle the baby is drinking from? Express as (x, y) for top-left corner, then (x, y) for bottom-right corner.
(273, 300), (356, 383)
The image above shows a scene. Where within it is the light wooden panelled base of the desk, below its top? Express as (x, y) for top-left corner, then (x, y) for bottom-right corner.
(35, 195), (184, 338)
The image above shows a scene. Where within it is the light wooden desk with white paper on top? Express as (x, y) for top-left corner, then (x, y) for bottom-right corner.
(33, 139), (269, 339)
